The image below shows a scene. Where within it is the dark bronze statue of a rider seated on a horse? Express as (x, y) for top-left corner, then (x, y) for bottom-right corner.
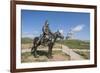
(31, 20), (64, 58)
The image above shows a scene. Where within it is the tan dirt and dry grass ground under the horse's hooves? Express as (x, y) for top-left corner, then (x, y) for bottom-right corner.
(21, 50), (70, 63)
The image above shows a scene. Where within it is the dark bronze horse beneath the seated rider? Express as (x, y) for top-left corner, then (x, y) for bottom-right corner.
(31, 31), (64, 58)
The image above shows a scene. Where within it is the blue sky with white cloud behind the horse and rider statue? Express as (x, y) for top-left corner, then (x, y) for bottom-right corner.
(21, 10), (90, 40)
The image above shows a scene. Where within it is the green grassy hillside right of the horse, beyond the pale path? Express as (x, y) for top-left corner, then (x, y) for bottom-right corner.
(58, 40), (90, 49)
